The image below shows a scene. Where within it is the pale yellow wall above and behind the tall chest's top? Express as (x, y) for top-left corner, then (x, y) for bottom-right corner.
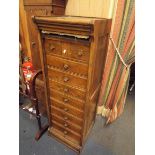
(65, 0), (116, 18)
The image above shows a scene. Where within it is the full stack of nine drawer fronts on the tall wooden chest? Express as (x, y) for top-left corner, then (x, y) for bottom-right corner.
(45, 38), (89, 148)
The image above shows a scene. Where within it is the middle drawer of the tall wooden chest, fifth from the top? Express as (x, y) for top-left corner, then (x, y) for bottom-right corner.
(50, 89), (85, 111)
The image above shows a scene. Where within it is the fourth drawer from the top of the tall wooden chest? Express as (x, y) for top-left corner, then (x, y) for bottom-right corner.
(48, 80), (86, 102)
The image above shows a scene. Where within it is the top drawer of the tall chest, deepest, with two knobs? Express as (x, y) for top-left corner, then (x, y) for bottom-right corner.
(45, 38), (89, 63)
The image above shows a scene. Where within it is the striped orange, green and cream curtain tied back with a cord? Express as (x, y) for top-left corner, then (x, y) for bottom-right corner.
(97, 0), (135, 123)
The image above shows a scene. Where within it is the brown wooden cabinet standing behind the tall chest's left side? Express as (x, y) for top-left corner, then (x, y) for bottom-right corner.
(24, 0), (66, 111)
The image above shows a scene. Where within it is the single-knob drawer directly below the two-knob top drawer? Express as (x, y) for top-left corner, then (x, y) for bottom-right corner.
(46, 55), (88, 77)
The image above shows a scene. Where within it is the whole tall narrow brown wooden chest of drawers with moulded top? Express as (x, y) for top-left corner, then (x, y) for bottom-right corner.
(34, 16), (111, 151)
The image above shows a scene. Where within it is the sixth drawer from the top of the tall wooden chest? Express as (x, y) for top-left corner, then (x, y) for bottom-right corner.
(51, 98), (83, 118)
